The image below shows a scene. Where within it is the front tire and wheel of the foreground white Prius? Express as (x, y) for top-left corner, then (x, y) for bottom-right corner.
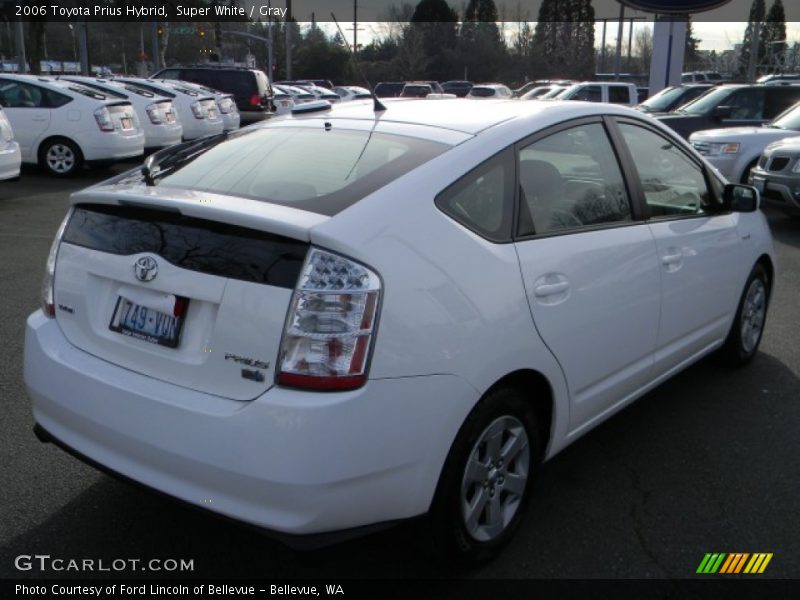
(719, 263), (770, 367)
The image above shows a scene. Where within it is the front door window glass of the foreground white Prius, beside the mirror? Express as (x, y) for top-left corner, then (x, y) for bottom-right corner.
(619, 123), (713, 218)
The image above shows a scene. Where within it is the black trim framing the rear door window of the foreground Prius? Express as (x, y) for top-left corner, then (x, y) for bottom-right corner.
(513, 115), (644, 242)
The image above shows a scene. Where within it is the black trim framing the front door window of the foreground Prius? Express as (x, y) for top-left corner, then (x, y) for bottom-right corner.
(607, 115), (726, 223)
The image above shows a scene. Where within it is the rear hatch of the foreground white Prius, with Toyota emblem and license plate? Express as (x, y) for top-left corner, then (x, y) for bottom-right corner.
(54, 188), (327, 400)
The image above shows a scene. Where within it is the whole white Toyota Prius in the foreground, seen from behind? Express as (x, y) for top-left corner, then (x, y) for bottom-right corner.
(25, 100), (775, 562)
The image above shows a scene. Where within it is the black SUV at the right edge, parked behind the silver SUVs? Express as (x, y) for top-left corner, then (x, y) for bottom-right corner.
(658, 84), (800, 139)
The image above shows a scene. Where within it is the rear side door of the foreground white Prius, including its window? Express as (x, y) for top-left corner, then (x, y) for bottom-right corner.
(515, 117), (660, 430)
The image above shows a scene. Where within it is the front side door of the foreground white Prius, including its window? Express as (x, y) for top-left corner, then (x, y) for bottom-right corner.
(617, 119), (741, 374)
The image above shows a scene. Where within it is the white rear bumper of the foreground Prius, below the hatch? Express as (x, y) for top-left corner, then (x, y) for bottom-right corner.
(25, 311), (477, 535)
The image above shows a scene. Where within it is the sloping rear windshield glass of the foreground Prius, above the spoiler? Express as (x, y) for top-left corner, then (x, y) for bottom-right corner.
(159, 126), (449, 215)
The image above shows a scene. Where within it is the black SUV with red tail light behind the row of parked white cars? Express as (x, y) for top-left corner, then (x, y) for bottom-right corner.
(152, 65), (275, 125)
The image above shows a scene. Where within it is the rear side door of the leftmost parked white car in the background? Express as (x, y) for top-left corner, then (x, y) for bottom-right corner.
(0, 78), (51, 162)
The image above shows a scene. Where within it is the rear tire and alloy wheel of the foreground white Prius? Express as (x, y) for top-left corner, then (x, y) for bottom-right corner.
(428, 388), (541, 565)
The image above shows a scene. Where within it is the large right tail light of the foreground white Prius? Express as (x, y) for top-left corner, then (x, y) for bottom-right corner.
(278, 248), (381, 390)
